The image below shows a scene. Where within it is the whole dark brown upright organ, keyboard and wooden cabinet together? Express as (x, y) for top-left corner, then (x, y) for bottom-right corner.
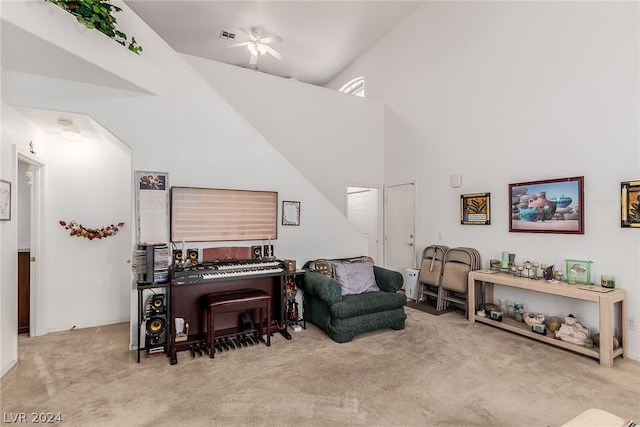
(169, 259), (291, 365)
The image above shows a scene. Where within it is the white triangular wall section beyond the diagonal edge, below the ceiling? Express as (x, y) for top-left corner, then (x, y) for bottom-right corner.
(182, 55), (384, 214)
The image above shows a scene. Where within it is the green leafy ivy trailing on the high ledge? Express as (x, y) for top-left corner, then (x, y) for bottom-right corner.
(45, 0), (142, 55)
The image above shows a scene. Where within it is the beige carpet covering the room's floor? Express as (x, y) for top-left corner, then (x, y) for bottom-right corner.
(0, 308), (640, 427)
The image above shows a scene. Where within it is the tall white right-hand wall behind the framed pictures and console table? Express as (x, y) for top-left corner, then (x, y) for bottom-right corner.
(329, 2), (640, 359)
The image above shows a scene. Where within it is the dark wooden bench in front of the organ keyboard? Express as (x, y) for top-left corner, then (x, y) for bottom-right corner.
(203, 289), (271, 358)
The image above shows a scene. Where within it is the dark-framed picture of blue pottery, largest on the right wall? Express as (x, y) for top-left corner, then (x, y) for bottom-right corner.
(509, 176), (584, 234)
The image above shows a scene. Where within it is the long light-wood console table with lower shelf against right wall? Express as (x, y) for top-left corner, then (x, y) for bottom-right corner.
(467, 270), (628, 367)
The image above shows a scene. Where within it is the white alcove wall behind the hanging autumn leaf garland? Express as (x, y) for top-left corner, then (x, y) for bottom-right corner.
(40, 136), (134, 332)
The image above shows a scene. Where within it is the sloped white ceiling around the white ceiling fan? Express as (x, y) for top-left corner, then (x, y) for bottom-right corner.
(125, 0), (423, 86)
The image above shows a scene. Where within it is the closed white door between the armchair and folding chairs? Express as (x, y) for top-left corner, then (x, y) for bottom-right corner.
(384, 182), (416, 273)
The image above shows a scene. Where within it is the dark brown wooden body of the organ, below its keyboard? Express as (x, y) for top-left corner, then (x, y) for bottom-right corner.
(169, 273), (288, 365)
